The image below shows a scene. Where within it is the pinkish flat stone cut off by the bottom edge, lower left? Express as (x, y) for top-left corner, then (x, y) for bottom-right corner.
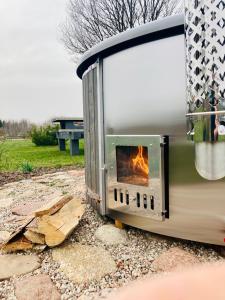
(15, 275), (61, 300)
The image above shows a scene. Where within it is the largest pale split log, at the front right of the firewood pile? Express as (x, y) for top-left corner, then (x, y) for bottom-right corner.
(32, 199), (85, 247)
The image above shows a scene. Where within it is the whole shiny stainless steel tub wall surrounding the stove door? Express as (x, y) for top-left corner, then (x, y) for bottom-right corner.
(103, 36), (225, 245)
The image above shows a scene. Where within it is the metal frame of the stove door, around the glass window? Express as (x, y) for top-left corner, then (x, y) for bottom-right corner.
(106, 135), (168, 221)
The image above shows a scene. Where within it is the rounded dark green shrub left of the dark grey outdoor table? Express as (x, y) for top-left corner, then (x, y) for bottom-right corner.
(31, 125), (59, 146)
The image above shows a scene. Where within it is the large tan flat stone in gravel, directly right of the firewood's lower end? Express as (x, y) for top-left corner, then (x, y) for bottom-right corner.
(52, 244), (116, 283)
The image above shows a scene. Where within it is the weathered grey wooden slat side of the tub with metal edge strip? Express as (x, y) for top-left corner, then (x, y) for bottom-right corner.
(83, 63), (105, 214)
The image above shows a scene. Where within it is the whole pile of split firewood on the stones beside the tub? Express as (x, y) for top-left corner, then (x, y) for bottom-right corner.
(1, 195), (85, 252)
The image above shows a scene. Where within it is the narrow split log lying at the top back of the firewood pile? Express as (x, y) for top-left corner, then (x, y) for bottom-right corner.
(34, 195), (73, 217)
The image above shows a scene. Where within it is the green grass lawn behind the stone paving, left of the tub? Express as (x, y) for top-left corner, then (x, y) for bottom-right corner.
(0, 140), (84, 171)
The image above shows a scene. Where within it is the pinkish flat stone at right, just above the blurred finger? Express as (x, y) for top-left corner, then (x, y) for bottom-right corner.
(152, 247), (199, 272)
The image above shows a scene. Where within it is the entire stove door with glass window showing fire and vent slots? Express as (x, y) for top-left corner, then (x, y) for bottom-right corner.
(106, 135), (168, 221)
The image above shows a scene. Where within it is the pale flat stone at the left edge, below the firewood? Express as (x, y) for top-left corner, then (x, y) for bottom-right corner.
(0, 254), (40, 280)
